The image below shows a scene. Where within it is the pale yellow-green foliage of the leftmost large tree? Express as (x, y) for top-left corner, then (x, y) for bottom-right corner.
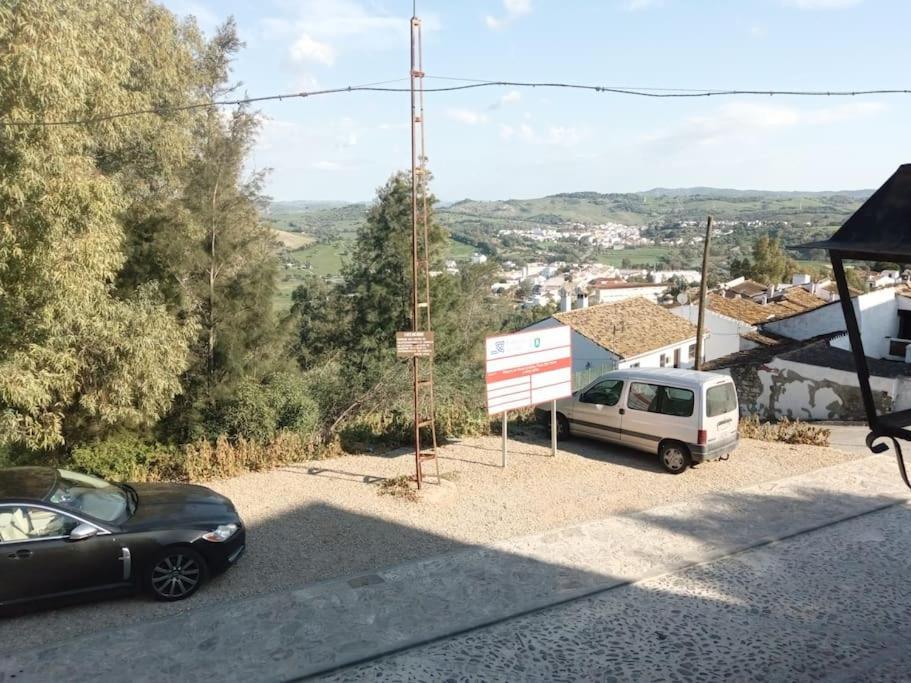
(0, 0), (208, 448)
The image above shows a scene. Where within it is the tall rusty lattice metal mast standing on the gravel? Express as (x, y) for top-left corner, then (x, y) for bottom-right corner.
(411, 3), (440, 488)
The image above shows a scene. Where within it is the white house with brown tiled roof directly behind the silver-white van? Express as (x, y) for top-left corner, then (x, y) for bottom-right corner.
(525, 297), (696, 373)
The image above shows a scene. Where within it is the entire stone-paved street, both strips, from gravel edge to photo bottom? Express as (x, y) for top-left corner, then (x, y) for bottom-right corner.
(0, 456), (911, 683)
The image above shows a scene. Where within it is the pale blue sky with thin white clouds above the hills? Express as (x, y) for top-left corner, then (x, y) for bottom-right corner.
(164, 0), (911, 201)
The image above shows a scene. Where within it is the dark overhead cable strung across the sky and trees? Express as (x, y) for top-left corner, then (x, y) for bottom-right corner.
(0, 76), (911, 127)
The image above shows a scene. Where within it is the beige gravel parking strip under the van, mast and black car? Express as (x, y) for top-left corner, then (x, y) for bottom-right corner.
(0, 428), (860, 652)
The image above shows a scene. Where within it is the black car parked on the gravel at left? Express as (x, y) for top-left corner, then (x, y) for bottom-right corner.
(0, 467), (245, 611)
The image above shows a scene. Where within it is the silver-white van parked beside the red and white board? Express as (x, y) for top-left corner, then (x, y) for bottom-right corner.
(535, 368), (739, 474)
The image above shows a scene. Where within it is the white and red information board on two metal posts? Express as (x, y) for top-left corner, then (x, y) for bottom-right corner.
(485, 325), (572, 467)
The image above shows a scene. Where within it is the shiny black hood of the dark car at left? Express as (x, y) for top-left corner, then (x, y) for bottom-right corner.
(122, 484), (240, 531)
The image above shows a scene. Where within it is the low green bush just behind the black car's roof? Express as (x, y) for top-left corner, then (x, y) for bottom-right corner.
(67, 434), (187, 481)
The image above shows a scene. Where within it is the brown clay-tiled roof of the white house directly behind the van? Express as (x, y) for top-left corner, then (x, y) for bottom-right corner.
(553, 297), (696, 359)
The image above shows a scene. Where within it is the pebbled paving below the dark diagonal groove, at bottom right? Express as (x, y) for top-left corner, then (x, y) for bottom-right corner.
(320, 505), (911, 681)
